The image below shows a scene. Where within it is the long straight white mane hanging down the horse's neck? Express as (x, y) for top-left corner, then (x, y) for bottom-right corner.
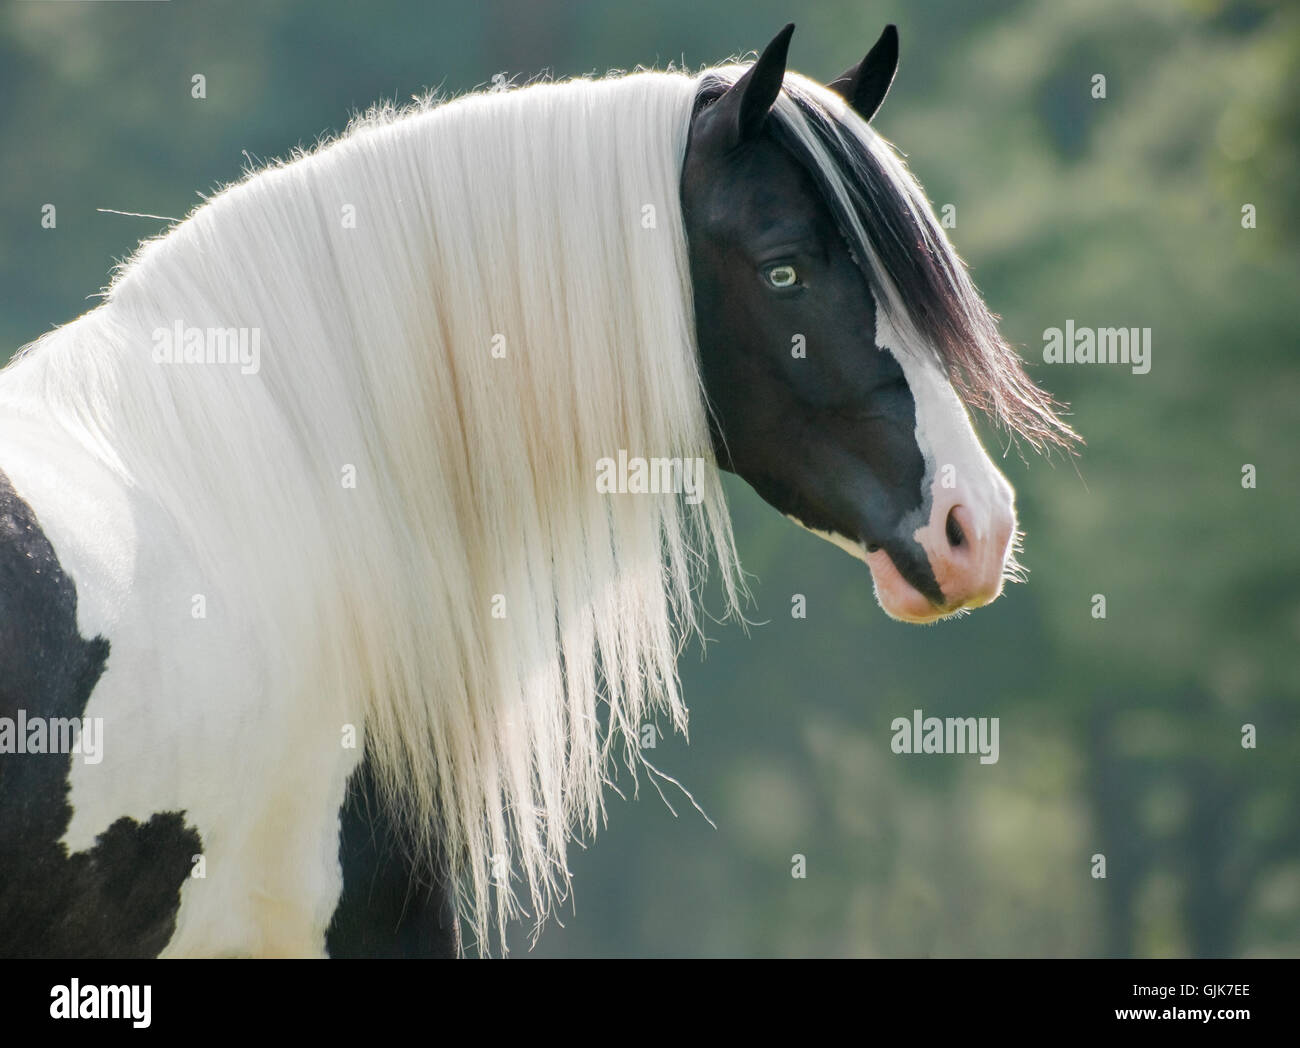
(5, 73), (738, 944)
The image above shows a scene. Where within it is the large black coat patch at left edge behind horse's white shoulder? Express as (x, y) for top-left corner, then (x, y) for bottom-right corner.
(0, 472), (203, 958)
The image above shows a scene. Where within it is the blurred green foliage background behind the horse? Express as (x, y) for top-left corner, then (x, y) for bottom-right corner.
(0, 0), (1300, 956)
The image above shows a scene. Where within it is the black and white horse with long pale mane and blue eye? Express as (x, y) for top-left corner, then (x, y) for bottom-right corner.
(0, 26), (1075, 957)
